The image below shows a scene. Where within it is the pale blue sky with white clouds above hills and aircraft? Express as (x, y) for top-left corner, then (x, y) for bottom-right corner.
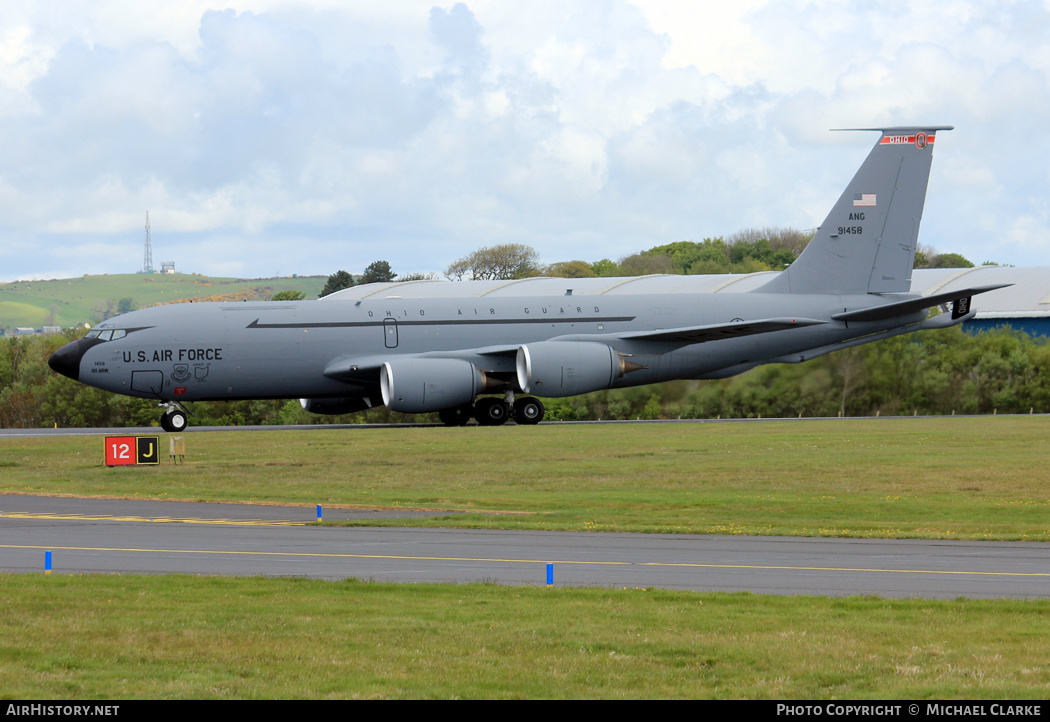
(0, 0), (1050, 281)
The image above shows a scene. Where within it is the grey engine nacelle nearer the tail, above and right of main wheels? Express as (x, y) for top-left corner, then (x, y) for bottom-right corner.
(517, 341), (625, 398)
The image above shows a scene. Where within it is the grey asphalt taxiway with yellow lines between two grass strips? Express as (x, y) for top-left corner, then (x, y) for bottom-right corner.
(0, 495), (1050, 599)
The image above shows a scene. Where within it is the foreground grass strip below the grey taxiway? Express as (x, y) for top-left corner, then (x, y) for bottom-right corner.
(0, 575), (1050, 699)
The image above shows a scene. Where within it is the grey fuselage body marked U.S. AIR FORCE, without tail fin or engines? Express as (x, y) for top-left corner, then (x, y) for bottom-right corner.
(61, 294), (926, 401)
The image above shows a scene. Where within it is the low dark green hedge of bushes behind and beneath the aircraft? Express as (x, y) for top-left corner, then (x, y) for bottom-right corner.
(0, 327), (1050, 428)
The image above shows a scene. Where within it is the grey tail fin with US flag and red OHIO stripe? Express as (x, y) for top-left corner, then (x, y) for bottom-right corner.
(756, 126), (951, 295)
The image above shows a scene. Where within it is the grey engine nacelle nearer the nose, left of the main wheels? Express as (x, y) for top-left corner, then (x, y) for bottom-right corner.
(379, 359), (488, 413)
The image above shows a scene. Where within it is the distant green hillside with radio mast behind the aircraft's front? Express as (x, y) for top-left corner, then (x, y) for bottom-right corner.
(0, 273), (327, 332)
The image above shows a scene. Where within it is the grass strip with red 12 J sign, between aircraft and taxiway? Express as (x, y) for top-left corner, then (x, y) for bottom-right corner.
(0, 417), (1050, 540)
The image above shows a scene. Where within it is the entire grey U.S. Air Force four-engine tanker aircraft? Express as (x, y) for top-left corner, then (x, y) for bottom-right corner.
(48, 126), (1002, 431)
